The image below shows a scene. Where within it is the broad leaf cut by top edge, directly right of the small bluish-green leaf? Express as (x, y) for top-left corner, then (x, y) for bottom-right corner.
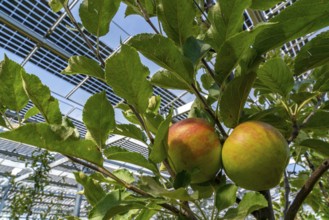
(206, 0), (251, 51)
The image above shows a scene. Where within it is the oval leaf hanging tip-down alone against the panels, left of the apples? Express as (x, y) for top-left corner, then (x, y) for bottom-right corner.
(82, 92), (115, 148)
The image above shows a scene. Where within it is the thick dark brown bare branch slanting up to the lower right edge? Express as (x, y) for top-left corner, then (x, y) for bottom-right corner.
(284, 159), (329, 220)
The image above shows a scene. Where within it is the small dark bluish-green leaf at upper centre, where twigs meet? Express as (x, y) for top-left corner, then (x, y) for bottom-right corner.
(183, 37), (211, 65)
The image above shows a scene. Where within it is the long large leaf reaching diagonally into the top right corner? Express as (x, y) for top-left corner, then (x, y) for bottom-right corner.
(254, 0), (329, 54)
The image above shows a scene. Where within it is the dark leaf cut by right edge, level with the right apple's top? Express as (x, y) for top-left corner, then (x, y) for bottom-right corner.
(302, 110), (329, 130)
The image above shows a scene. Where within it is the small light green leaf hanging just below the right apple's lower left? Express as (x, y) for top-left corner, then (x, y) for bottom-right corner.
(215, 184), (238, 211)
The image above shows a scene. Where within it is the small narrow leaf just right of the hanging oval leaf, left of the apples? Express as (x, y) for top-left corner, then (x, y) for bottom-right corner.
(113, 124), (147, 143)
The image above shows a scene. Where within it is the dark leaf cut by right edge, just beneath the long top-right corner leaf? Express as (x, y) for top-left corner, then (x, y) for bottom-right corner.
(295, 31), (329, 74)
